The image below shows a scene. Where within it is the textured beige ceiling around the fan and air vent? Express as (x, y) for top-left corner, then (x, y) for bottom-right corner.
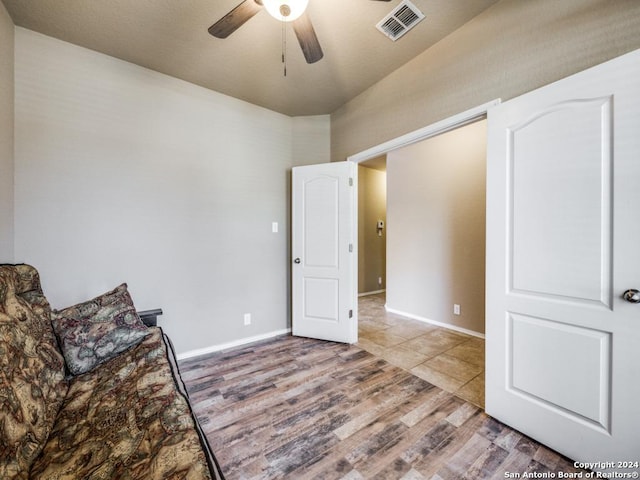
(2, 0), (498, 116)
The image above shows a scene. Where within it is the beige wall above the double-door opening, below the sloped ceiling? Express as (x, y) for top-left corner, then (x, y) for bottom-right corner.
(331, 0), (640, 161)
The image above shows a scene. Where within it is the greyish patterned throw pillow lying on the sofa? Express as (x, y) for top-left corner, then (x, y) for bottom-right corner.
(52, 283), (148, 375)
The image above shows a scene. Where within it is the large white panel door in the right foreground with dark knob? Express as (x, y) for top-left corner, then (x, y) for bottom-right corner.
(486, 51), (640, 466)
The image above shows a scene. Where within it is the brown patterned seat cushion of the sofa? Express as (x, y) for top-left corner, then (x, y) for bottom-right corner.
(30, 327), (211, 480)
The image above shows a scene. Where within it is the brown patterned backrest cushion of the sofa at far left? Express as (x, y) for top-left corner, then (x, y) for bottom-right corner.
(0, 265), (67, 479)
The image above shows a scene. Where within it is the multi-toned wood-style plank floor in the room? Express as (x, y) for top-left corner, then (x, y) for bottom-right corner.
(180, 336), (576, 480)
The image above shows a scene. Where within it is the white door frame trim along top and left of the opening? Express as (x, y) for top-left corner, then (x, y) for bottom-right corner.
(347, 98), (502, 332)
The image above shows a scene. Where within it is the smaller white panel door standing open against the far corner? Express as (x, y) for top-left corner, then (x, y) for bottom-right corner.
(291, 162), (358, 343)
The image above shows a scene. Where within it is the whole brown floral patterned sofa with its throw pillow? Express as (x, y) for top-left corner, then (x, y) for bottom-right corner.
(0, 265), (222, 480)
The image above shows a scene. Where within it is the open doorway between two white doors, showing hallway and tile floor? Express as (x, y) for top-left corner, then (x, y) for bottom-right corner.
(358, 114), (486, 407)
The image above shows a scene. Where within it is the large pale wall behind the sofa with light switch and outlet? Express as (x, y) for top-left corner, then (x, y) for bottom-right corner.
(15, 28), (329, 352)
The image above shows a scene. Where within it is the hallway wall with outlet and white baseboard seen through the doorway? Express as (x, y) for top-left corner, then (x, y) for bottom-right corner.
(387, 120), (486, 333)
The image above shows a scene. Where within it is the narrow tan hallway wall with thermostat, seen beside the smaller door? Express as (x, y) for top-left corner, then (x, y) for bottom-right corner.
(358, 166), (387, 293)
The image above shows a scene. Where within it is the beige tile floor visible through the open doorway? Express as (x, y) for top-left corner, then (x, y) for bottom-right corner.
(358, 293), (484, 408)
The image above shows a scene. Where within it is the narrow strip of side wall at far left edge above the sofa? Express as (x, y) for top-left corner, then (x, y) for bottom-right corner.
(0, 2), (14, 263)
